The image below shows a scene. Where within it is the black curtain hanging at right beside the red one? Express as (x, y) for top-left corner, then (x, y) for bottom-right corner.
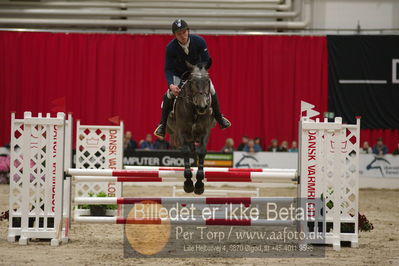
(327, 35), (399, 129)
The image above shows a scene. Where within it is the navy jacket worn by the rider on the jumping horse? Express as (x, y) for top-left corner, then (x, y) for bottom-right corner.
(165, 34), (212, 88)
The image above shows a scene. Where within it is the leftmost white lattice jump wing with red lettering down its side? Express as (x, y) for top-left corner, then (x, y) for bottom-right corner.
(8, 112), (67, 245)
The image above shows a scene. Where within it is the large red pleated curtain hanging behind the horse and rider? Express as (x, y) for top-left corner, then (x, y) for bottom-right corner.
(0, 32), (328, 150)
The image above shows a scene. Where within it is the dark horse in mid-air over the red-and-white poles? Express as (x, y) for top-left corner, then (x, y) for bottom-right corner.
(167, 64), (216, 194)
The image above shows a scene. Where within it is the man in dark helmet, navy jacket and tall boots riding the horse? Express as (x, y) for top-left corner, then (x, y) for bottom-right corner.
(154, 19), (231, 137)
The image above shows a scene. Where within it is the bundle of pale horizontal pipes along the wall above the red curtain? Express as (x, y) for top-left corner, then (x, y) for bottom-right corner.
(0, 0), (310, 33)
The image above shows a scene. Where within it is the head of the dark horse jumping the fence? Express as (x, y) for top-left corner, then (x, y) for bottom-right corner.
(187, 63), (211, 115)
